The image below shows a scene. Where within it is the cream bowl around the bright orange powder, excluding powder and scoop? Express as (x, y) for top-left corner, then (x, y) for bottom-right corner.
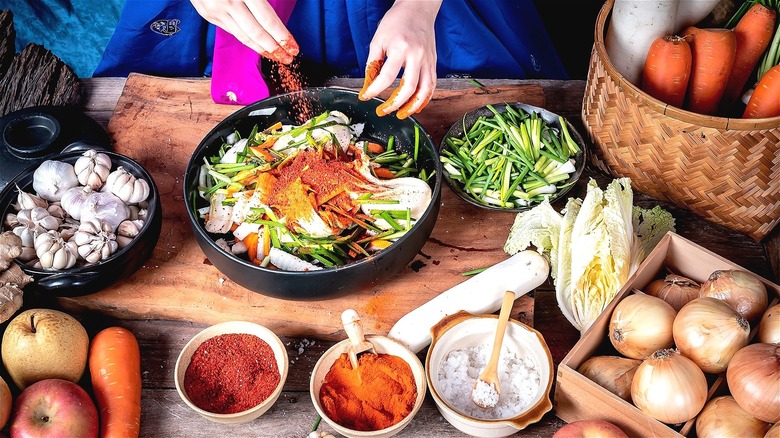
(309, 335), (426, 438)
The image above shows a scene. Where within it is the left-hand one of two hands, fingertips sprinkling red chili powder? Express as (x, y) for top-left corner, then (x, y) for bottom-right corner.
(190, 0), (299, 64)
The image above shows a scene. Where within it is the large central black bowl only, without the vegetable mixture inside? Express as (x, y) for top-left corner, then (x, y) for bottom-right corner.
(184, 88), (441, 300)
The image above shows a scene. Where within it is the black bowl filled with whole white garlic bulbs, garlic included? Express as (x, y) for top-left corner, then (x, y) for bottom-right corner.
(0, 147), (162, 296)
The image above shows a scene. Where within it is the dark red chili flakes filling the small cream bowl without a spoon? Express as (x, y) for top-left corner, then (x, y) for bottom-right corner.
(184, 333), (281, 414)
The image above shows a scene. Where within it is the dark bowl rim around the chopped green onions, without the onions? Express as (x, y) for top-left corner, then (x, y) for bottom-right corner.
(439, 102), (587, 212)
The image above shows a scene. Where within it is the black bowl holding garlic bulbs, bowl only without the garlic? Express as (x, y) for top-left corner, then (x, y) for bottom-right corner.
(0, 149), (162, 299)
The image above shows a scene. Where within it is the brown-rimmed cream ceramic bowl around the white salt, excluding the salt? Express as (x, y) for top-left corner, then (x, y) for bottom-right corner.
(425, 311), (554, 437)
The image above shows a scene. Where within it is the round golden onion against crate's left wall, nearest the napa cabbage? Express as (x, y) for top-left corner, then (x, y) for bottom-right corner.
(609, 290), (677, 359)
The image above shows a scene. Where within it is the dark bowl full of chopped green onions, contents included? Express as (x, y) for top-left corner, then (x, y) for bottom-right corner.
(440, 103), (586, 212)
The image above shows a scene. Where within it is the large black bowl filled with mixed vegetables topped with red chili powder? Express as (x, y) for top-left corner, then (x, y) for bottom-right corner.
(185, 88), (441, 299)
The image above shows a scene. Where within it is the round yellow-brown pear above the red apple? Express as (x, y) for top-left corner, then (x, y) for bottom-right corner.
(1, 309), (89, 389)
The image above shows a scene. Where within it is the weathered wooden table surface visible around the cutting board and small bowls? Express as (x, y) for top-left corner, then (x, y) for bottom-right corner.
(64, 78), (780, 437)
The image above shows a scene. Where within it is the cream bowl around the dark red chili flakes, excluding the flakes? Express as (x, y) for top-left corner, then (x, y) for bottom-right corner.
(174, 321), (289, 424)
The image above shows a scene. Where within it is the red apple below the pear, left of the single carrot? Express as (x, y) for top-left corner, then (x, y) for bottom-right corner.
(11, 379), (98, 438)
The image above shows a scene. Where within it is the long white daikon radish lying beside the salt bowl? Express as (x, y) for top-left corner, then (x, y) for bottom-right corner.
(387, 250), (550, 353)
